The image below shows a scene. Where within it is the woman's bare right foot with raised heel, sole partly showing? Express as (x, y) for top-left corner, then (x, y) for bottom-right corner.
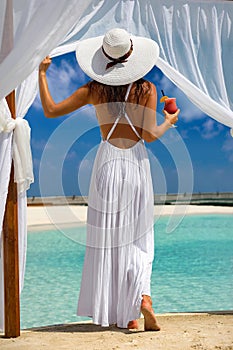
(141, 295), (160, 331)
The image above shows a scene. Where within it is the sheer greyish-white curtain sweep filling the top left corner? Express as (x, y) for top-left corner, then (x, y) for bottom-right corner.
(0, 0), (92, 100)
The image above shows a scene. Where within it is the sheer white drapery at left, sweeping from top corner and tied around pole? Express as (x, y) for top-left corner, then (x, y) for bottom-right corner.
(0, 0), (91, 330)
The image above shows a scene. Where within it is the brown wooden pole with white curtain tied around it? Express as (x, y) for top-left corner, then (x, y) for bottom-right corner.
(3, 91), (20, 338)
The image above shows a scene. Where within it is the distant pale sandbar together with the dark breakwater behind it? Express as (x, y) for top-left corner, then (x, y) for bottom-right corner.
(27, 192), (233, 228)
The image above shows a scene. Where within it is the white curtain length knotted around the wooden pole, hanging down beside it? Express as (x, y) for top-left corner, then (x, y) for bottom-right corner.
(0, 71), (37, 330)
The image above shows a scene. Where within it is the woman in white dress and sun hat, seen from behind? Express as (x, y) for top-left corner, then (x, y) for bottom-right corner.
(39, 28), (179, 331)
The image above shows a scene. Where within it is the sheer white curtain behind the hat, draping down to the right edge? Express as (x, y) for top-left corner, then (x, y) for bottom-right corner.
(49, 0), (233, 127)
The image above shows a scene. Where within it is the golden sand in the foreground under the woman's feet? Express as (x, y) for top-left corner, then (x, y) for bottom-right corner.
(0, 313), (233, 350)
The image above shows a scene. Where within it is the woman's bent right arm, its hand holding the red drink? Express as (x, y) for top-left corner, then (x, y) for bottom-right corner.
(142, 83), (180, 142)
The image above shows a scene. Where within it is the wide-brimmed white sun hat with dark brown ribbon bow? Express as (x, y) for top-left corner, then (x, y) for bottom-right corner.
(76, 28), (159, 85)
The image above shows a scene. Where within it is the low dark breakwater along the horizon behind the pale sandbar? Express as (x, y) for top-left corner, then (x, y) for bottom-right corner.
(27, 192), (233, 207)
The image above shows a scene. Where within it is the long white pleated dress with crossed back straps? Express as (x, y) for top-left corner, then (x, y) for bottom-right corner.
(77, 85), (154, 328)
